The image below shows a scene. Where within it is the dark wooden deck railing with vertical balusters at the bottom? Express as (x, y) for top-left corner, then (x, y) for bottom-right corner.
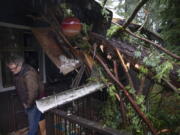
(46, 109), (128, 135)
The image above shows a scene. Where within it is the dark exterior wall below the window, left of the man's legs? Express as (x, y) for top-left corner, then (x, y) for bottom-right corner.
(0, 91), (27, 133)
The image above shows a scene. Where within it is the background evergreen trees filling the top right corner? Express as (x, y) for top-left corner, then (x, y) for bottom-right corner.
(145, 0), (180, 55)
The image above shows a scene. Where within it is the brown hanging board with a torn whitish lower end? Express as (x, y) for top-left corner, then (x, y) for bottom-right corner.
(32, 28), (80, 75)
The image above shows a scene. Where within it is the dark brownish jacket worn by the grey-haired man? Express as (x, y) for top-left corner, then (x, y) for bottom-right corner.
(14, 64), (44, 108)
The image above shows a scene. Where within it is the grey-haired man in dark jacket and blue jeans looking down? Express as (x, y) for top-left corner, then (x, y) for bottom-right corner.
(6, 55), (45, 135)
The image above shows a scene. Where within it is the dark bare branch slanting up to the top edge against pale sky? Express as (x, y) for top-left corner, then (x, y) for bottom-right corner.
(123, 0), (148, 29)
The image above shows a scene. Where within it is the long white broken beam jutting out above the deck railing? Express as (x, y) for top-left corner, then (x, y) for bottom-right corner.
(36, 83), (105, 113)
